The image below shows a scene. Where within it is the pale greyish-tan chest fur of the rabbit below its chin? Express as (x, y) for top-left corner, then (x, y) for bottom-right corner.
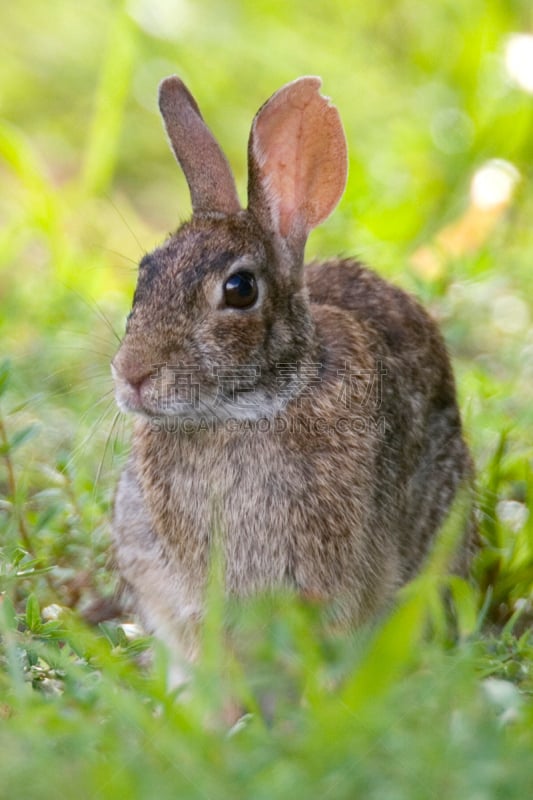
(160, 432), (301, 593)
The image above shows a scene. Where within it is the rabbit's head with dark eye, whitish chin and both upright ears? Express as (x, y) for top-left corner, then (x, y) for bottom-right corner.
(112, 77), (347, 419)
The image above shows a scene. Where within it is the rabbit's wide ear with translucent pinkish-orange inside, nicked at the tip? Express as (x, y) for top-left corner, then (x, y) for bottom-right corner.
(248, 77), (348, 249)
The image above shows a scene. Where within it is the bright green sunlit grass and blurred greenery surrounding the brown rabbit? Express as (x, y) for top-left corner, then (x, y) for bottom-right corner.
(0, 0), (533, 800)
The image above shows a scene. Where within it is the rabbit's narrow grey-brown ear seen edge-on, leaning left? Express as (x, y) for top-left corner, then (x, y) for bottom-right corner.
(159, 75), (241, 214)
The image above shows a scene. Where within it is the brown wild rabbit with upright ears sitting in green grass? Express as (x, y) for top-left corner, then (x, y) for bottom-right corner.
(111, 76), (474, 674)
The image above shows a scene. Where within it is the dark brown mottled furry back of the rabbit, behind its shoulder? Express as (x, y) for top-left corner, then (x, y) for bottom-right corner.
(306, 260), (474, 578)
